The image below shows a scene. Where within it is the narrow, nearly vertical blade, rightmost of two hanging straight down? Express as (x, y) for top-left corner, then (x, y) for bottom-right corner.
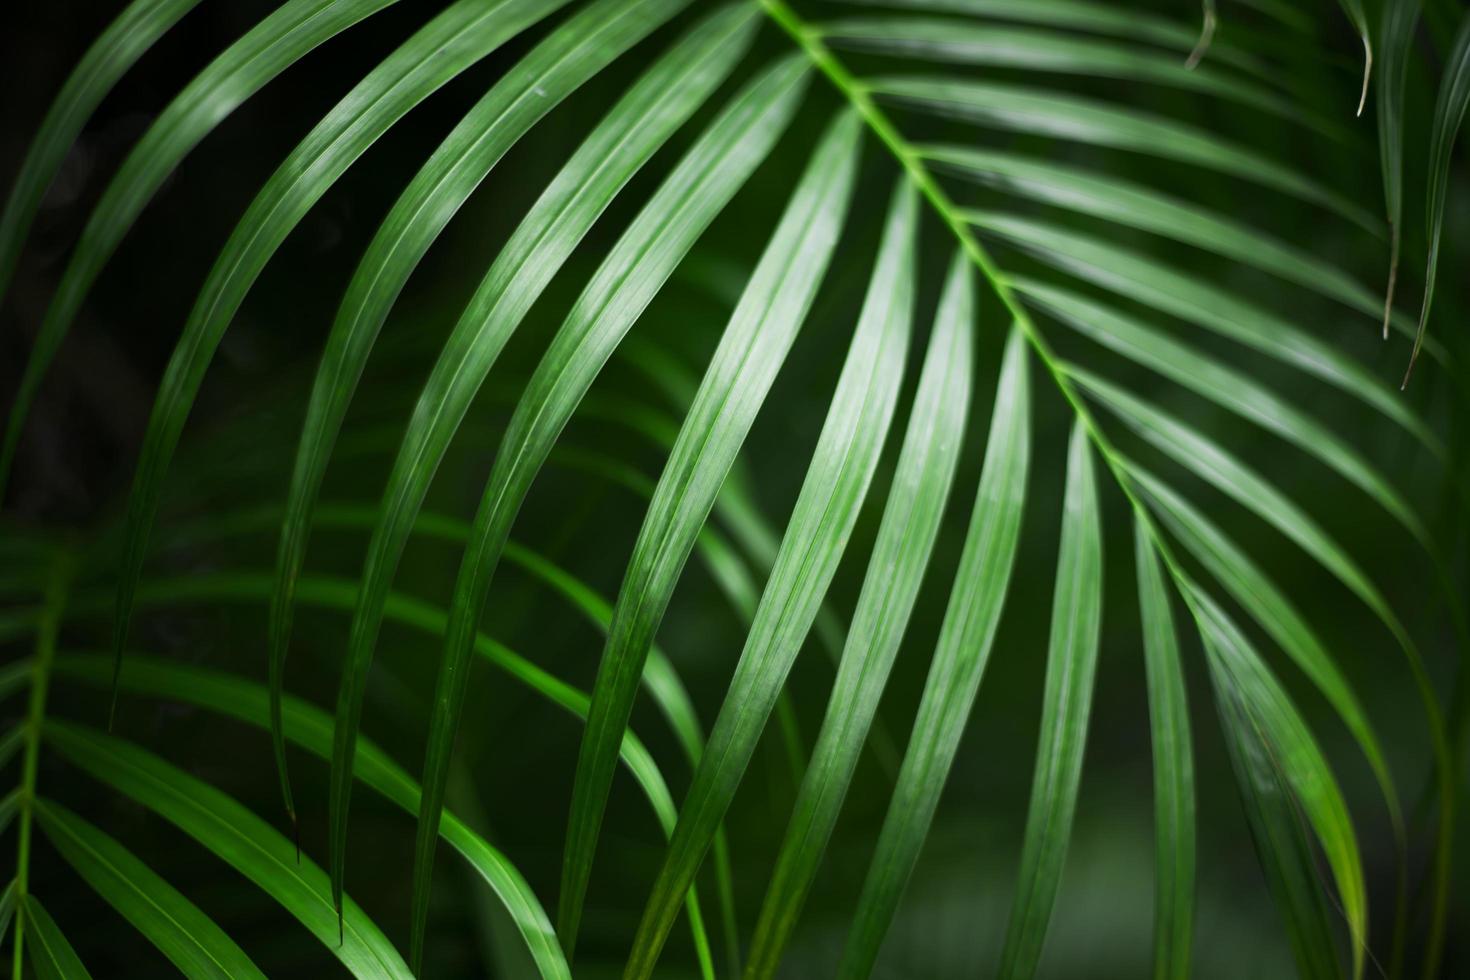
(1133, 522), (1195, 980)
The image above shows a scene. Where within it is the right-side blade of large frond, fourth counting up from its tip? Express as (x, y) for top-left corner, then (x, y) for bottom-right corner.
(1016, 281), (1433, 550)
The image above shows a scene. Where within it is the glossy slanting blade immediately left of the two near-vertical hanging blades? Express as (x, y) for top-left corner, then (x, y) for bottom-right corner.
(838, 328), (1030, 980)
